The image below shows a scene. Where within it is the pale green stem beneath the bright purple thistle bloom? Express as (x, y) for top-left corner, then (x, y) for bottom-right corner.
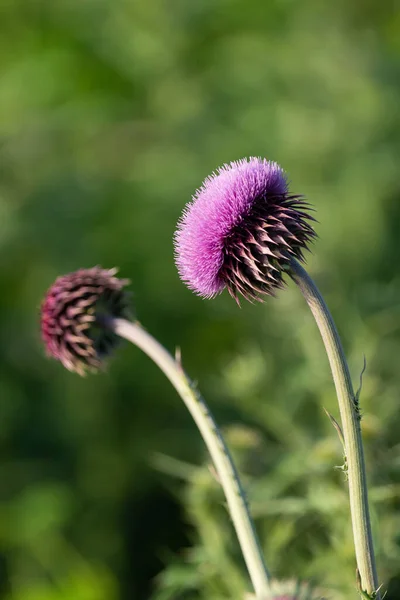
(290, 259), (380, 600)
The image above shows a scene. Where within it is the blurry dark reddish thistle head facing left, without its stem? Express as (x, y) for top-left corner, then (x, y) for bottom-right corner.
(41, 267), (129, 375)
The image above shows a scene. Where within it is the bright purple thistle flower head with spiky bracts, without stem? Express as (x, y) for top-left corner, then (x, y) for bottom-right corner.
(174, 158), (315, 301)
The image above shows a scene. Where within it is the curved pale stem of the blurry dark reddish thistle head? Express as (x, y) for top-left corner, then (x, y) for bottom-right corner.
(103, 319), (270, 600)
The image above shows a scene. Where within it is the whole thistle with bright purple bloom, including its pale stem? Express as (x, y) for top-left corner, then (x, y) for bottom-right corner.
(175, 158), (380, 598)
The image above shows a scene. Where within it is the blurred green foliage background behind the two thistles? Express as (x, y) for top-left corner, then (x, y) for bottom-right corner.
(0, 0), (400, 600)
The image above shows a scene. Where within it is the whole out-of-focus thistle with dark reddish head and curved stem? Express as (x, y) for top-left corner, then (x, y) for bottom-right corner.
(41, 267), (273, 600)
